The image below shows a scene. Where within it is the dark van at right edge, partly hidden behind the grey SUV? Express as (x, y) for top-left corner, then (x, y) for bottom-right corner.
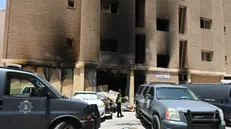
(183, 84), (231, 124)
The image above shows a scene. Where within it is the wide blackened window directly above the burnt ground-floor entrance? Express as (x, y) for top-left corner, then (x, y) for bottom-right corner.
(100, 39), (118, 52)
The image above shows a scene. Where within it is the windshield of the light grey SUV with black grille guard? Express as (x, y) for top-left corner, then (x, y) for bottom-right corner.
(156, 87), (198, 100)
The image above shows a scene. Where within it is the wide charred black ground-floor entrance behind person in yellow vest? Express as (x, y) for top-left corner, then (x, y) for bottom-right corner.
(97, 69), (128, 96)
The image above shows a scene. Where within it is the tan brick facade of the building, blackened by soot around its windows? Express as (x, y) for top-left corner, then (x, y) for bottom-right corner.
(3, 0), (231, 95)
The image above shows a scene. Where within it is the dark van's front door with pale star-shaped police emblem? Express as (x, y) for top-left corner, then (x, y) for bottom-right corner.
(0, 72), (48, 129)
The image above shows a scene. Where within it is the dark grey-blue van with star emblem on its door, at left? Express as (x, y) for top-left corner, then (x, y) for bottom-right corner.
(0, 67), (101, 129)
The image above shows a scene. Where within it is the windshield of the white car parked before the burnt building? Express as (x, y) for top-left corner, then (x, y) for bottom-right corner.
(72, 93), (98, 100)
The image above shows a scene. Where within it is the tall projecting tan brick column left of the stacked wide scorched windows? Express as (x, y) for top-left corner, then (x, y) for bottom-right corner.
(79, 0), (101, 62)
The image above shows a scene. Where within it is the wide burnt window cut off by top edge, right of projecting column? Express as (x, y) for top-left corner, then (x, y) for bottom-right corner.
(101, 0), (119, 14)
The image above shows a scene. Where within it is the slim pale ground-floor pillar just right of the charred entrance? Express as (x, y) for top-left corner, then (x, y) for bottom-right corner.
(129, 70), (135, 104)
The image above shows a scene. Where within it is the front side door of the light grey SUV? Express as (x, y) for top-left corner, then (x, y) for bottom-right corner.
(144, 87), (154, 118)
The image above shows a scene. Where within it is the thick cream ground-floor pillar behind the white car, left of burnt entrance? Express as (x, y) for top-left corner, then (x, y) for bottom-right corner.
(72, 66), (84, 93)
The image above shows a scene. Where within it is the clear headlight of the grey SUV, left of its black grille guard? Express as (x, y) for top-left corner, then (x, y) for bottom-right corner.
(165, 108), (180, 121)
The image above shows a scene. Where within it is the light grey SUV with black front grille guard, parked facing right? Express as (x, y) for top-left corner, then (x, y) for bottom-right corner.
(136, 84), (226, 129)
